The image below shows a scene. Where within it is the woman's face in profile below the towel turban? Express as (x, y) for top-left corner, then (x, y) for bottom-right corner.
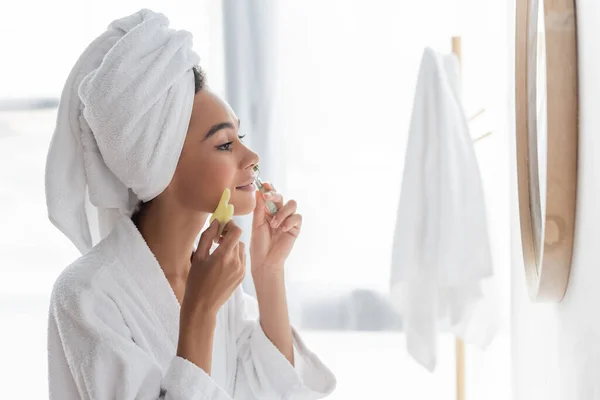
(169, 88), (258, 215)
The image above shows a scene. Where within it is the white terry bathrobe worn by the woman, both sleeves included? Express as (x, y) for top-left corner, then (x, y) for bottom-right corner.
(48, 217), (336, 400)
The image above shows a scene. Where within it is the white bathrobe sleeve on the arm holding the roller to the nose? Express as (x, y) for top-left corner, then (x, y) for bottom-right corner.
(232, 286), (336, 400)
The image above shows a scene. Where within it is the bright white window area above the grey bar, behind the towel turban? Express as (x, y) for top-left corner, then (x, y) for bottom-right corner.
(0, 0), (224, 98)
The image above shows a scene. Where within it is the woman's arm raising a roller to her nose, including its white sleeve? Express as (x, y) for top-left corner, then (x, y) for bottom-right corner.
(236, 183), (336, 400)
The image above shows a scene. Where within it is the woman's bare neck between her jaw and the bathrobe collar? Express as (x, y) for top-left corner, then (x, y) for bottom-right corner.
(134, 201), (208, 283)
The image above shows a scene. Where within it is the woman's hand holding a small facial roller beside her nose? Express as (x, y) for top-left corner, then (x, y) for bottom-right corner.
(250, 183), (302, 273)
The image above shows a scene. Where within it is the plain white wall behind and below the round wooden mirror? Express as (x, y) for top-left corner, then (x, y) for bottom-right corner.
(511, 0), (600, 400)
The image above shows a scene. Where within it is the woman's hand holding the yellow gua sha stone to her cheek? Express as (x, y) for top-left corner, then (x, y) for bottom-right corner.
(181, 220), (246, 317)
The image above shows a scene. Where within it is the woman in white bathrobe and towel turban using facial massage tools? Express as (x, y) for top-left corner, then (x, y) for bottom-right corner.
(46, 9), (335, 400)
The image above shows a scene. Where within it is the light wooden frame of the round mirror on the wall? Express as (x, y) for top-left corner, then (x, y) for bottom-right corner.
(515, 0), (578, 301)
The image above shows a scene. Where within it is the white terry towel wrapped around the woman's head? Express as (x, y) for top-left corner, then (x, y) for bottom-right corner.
(46, 9), (200, 253)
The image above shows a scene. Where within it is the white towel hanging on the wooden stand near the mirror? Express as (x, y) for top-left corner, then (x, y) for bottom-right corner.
(390, 48), (499, 371)
